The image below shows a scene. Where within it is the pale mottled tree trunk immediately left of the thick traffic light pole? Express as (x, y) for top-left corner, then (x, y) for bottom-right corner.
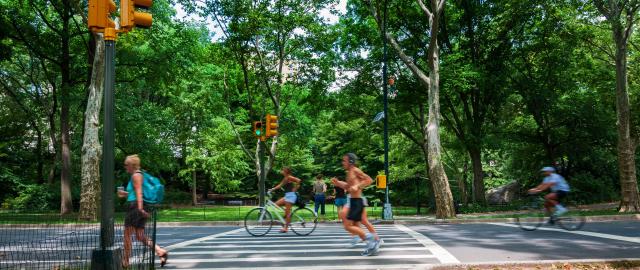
(80, 34), (105, 220)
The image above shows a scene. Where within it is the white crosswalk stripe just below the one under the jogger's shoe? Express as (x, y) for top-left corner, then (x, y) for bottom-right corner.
(165, 254), (436, 262)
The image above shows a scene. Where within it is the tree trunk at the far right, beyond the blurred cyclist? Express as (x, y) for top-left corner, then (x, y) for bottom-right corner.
(613, 26), (640, 212)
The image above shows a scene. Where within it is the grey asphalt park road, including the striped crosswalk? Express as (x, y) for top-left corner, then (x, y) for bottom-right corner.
(0, 222), (640, 270)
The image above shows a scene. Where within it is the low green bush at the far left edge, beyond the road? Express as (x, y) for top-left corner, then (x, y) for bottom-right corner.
(3, 184), (57, 211)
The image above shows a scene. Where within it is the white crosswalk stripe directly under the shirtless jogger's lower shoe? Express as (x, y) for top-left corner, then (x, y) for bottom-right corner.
(171, 247), (429, 255)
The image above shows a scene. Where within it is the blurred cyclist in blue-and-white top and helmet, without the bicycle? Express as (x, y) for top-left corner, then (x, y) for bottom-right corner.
(529, 167), (570, 223)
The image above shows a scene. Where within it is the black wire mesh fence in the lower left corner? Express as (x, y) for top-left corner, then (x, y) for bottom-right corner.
(0, 210), (156, 270)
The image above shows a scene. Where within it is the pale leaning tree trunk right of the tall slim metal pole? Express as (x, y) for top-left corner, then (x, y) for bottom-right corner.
(425, 44), (456, 218)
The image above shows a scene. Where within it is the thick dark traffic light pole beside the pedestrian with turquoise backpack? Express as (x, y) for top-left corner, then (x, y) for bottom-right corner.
(91, 28), (122, 270)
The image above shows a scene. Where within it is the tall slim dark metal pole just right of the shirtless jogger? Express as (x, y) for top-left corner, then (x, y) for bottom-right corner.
(382, 0), (393, 220)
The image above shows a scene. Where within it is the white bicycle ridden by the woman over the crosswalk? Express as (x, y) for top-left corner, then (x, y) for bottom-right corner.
(244, 192), (318, 236)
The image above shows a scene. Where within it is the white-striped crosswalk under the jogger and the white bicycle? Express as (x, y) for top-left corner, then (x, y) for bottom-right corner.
(165, 225), (458, 270)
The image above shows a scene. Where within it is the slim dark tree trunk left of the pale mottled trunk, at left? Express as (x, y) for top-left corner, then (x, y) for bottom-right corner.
(60, 0), (73, 215)
